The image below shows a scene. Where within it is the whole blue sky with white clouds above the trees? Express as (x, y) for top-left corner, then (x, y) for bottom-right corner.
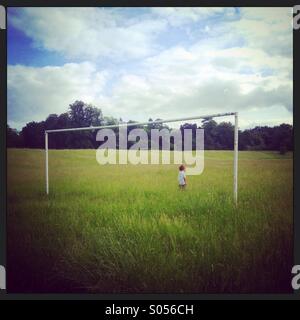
(7, 8), (293, 129)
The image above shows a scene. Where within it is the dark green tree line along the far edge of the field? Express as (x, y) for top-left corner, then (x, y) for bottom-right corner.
(7, 101), (293, 153)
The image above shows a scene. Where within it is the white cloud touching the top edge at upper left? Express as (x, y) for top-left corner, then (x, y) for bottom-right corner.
(8, 8), (166, 60)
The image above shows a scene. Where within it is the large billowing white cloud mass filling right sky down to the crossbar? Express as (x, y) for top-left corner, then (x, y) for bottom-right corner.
(99, 28), (292, 126)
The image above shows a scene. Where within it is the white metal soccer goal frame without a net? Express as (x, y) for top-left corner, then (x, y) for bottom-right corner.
(45, 112), (238, 204)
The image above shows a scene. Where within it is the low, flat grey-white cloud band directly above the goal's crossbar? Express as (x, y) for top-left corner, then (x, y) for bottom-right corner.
(107, 76), (292, 121)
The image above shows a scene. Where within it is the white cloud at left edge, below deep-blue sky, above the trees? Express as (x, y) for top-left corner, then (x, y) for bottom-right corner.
(7, 62), (108, 128)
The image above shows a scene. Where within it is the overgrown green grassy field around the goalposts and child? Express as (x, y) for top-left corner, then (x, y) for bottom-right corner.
(7, 149), (293, 293)
